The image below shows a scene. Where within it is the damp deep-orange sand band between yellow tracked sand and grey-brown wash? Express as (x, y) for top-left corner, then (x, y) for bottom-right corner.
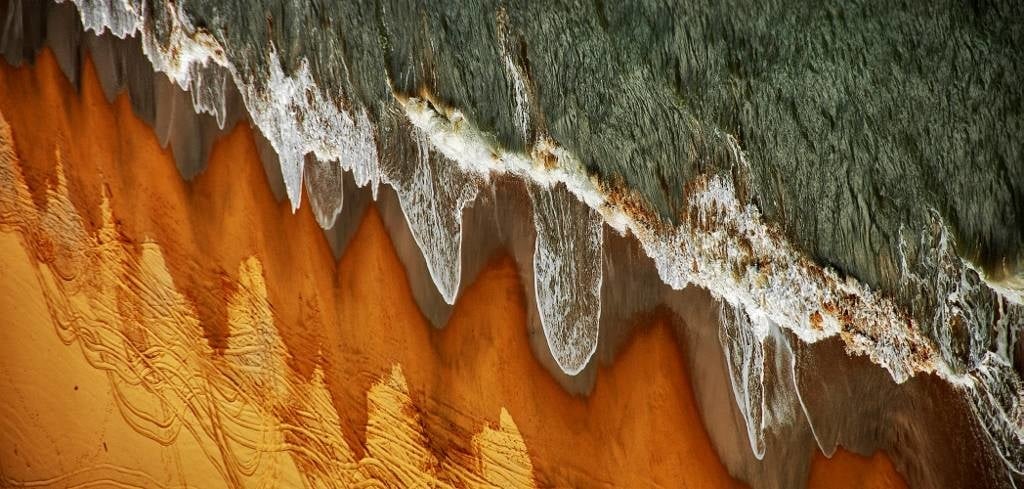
(2, 46), (913, 485)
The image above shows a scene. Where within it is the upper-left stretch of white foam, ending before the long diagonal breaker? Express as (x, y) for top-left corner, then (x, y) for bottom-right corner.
(72, 0), (380, 210)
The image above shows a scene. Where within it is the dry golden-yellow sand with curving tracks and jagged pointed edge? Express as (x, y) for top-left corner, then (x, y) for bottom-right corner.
(0, 120), (534, 487)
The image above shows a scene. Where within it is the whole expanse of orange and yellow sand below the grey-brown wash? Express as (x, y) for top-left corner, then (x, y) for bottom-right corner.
(0, 46), (901, 487)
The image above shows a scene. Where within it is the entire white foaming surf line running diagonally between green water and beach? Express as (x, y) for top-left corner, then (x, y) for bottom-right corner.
(29, 0), (1024, 474)
